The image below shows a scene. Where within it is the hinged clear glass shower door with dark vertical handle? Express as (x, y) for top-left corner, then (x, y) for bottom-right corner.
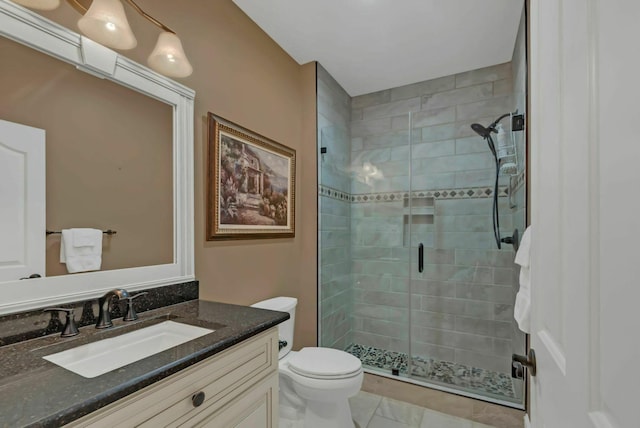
(405, 110), (524, 405)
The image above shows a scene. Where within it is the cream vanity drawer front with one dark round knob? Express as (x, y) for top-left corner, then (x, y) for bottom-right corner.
(68, 328), (278, 428)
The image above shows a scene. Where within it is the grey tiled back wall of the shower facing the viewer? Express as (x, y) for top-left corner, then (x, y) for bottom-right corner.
(350, 63), (519, 372)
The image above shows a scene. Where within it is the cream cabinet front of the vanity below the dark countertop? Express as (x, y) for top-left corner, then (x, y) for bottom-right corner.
(66, 329), (278, 428)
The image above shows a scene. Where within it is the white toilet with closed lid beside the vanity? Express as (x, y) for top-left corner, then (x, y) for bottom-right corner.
(251, 297), (364, 428)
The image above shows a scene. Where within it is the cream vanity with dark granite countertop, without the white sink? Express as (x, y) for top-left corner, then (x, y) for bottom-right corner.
(0, 300), (288, 428)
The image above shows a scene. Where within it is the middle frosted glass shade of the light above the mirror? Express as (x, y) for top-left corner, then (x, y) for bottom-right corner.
(78, 0), (138, 49)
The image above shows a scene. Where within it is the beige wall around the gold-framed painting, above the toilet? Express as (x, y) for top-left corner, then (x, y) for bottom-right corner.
(31, 0), (317, 348)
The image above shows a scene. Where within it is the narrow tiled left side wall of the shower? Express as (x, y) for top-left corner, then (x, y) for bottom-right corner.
(317, 64), (353, 349)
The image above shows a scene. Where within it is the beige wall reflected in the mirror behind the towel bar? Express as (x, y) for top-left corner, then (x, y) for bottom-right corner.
(0, 37), (173, 276)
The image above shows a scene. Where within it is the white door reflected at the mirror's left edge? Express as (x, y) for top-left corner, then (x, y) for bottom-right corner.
(0, 120), (45, 281)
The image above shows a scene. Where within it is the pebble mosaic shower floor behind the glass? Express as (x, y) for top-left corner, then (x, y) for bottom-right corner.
(346, 343), (516, 400)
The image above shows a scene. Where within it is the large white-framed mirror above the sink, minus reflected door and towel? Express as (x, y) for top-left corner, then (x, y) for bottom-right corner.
(0, 0), (194, 314)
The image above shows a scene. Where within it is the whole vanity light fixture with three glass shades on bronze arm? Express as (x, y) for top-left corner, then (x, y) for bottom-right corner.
(13, 0), (193, 77)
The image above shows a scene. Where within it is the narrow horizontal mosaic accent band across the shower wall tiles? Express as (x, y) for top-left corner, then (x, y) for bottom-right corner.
(318, 185), (510, 203)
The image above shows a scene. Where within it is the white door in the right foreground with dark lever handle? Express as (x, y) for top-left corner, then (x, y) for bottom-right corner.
(529, 0), (640, 428)
